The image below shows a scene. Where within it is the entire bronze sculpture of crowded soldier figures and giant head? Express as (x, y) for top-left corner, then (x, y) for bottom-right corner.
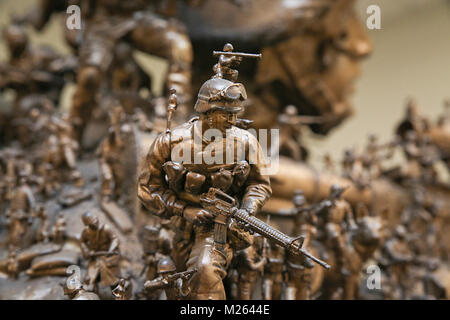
(0, 0), (450, 300)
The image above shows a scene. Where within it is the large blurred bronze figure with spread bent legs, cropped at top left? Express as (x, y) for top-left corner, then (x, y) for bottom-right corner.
(65, 0), (197, 141)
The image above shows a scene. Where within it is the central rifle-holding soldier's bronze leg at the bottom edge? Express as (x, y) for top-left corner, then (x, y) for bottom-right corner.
(187, 231), (233, 300)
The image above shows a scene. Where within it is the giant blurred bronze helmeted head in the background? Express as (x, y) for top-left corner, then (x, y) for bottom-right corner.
(183, 0), (372, 134)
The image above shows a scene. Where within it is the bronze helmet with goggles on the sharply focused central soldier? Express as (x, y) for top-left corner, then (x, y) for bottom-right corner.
(194, 78), (247, 113)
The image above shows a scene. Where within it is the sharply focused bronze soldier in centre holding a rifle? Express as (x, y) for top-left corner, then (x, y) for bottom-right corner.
(138, 58), (271, 299)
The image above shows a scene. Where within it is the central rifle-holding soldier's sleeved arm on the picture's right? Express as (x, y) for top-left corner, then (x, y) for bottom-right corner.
(241, 133), (272, 215)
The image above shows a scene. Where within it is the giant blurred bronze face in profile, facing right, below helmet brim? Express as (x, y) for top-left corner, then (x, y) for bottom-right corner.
(260, 0), (372, 133)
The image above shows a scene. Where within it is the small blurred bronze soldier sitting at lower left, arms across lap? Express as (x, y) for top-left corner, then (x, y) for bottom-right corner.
(80, 211), (120, 287)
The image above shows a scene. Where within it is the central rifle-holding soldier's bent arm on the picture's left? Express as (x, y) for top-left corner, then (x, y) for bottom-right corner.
(138, 133), (186, 218)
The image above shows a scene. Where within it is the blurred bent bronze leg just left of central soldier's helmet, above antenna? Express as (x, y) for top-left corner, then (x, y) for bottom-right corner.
(130, 12), (193, 104)
